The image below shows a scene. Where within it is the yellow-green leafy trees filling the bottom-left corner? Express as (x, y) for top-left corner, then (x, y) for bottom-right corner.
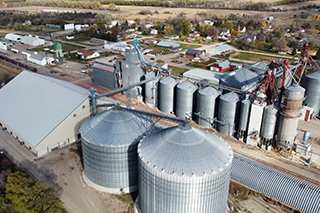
(0, 154), (66, 213)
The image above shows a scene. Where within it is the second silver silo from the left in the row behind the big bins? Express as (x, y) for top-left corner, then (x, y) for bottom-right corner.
(159, 77), (178, 113)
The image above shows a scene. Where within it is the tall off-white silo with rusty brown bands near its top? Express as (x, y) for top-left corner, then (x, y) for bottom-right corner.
(278, 84), (305, 148)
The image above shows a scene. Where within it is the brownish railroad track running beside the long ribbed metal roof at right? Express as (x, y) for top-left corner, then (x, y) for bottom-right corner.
(233, 150), (320, 187)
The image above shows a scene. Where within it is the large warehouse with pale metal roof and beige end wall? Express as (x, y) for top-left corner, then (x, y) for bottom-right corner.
(0, 71), (112, 156)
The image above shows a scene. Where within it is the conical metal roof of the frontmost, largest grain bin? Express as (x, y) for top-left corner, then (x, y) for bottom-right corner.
(138, 125), (233, 177)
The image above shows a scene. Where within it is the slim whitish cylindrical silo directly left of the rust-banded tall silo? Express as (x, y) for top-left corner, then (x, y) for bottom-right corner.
(261, 105), (278, 146)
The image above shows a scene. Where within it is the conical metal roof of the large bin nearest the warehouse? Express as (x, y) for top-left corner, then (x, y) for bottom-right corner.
(79, 108), (153, 146)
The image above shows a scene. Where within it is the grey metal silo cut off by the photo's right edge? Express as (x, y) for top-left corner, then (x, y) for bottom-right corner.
(304, 71), (320, 117)
